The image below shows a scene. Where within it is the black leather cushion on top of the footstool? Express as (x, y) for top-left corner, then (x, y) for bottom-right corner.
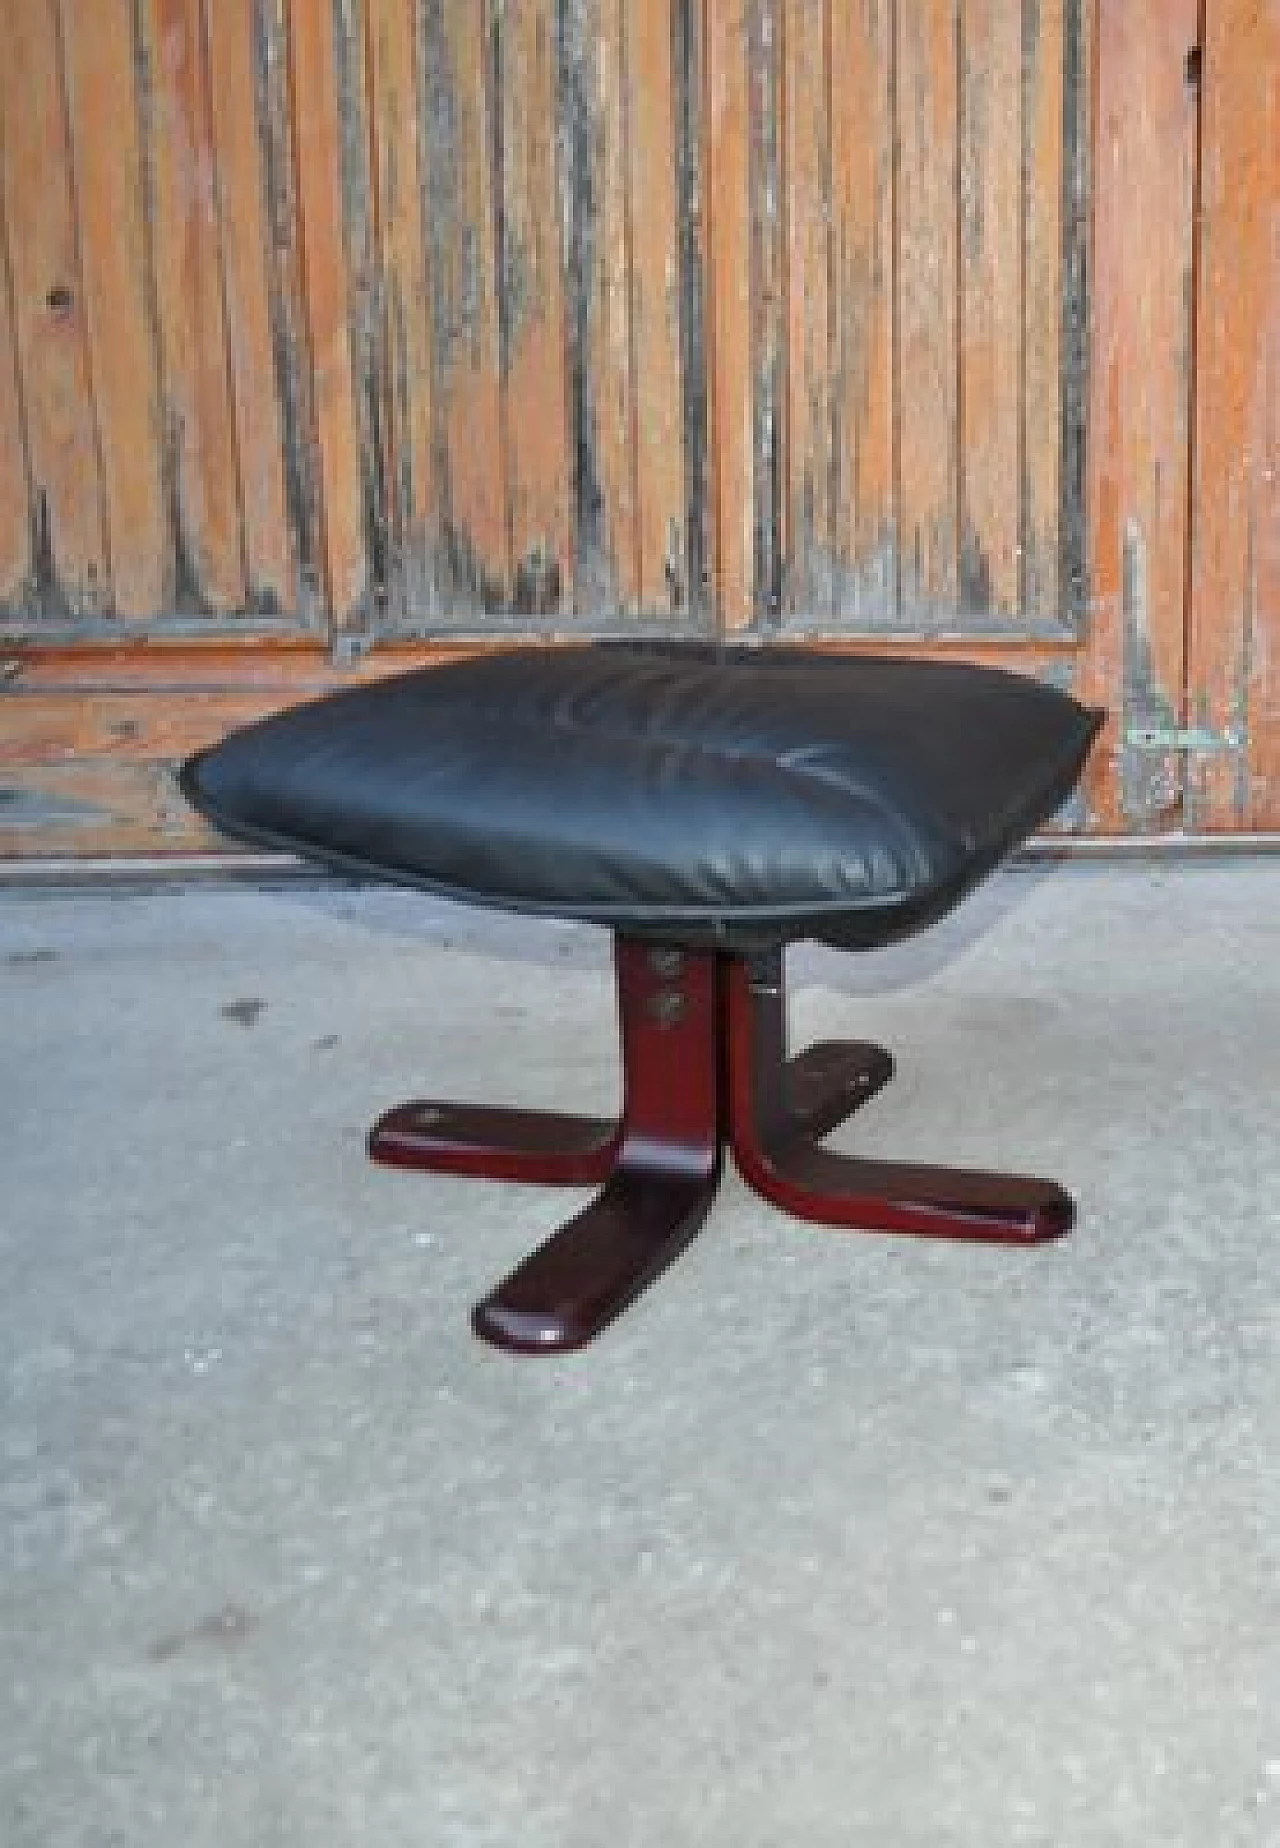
(183, 643), (1101, 948)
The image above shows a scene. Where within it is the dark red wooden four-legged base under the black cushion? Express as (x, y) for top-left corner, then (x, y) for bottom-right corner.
(369, 937), (1073, 1353)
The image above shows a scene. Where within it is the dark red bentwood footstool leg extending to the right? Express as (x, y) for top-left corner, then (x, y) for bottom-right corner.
(720, 952), (1073, 1244)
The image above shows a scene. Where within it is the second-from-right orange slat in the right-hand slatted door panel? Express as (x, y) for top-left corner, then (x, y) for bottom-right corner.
(960, 0), (1019, 623)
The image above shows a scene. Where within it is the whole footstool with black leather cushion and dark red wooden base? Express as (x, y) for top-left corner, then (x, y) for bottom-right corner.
(181, 643), (1103, 1353)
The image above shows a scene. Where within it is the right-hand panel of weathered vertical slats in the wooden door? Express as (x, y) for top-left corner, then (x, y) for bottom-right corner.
(707, 0), (1092, 638)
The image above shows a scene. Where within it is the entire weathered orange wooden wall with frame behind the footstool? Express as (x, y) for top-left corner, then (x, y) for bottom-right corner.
(0, 0), (1280, 850)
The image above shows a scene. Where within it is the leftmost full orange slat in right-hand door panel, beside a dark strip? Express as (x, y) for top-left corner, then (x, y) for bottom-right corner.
(783, 0), (835, 619)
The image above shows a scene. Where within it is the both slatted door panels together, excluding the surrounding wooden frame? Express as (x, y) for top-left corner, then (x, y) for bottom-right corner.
(0, 0), (1090, 645)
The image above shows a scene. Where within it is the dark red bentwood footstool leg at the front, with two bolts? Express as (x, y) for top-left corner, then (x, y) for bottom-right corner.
(471, 937), (720, 1353)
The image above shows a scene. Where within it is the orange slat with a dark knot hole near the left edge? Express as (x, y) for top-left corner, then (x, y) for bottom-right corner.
(0, 0), (111, 617)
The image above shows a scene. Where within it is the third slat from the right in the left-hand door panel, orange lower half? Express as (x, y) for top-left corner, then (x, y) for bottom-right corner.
(495, 0), (573, 615)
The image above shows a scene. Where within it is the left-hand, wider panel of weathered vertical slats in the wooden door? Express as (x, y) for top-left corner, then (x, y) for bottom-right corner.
(0, 0), (707, 649)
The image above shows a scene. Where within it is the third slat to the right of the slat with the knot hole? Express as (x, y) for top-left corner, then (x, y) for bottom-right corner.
(205, 0), (299, 614)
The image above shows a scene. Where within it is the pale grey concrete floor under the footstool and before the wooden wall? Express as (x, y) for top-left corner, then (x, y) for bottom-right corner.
(0, 861), (1280, 1848)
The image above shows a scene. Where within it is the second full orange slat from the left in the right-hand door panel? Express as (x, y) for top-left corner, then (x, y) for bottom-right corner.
(831, 0), (898, 626)
